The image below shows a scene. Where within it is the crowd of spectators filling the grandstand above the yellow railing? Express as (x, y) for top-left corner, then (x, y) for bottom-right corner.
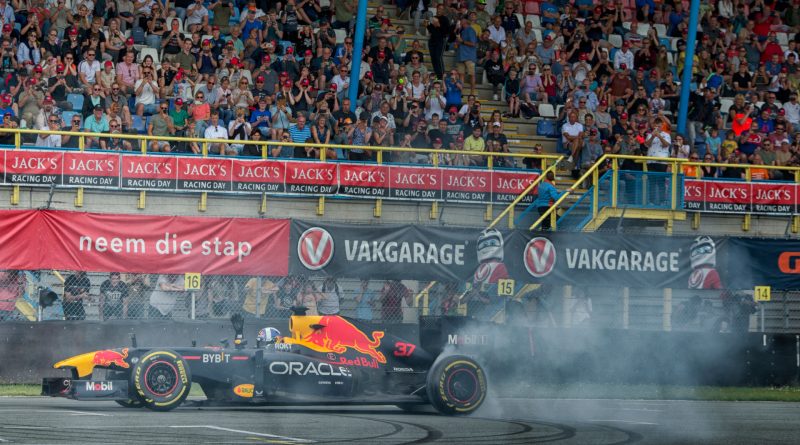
(0, 0), (800, 177)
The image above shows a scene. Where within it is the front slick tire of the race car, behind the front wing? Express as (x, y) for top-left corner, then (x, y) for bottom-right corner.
(131, 349), (192, 411)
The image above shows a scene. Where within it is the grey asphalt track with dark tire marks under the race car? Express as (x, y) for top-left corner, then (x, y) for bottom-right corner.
(0, 397), (800, 445)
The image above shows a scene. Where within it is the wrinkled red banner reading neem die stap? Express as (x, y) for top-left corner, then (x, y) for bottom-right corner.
(0, 210), (289, 276)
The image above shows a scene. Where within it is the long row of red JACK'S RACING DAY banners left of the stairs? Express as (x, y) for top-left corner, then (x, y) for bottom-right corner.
(0, 149), (539, 204)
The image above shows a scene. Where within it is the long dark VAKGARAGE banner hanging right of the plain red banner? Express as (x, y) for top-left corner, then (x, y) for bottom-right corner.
(289, 220), (800, 289)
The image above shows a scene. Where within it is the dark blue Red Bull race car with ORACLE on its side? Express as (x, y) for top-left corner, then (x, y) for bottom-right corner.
(42, 308), (487, 415)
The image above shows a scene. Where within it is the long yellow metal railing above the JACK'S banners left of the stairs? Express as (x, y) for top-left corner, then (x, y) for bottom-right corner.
(0, 128), (561, 215)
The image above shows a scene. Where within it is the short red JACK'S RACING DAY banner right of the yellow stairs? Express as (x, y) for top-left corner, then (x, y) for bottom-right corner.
(683, 178), (800, 215)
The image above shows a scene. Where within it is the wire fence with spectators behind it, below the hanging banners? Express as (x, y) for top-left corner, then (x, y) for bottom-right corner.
(0, 271), (788, 333)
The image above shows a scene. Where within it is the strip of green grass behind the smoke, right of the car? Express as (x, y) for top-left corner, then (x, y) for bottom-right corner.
(499, 384), (800, 402)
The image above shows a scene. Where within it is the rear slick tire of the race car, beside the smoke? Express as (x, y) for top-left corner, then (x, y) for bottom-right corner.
(426, 355), (487, 416)
